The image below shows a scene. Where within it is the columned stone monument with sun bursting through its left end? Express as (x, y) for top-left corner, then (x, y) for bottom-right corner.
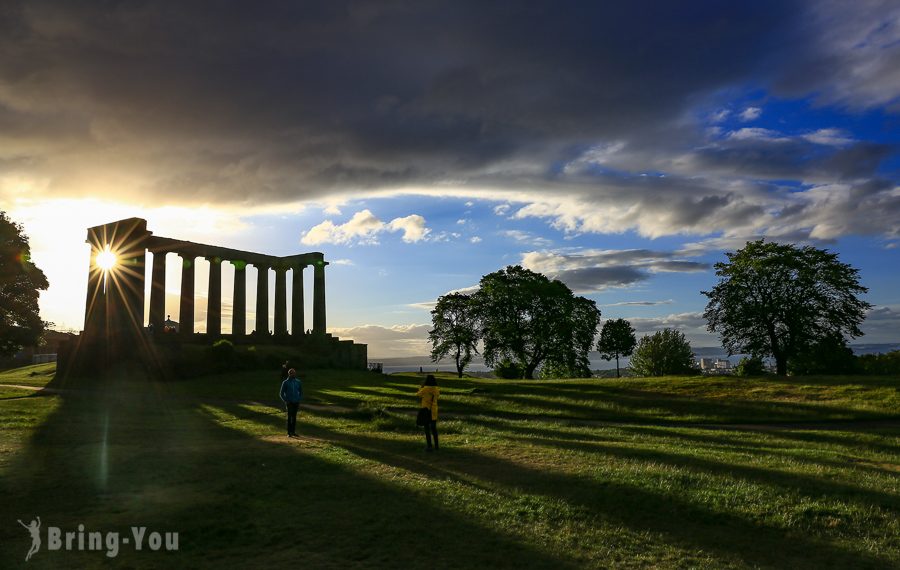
(60, 218), (366, 374)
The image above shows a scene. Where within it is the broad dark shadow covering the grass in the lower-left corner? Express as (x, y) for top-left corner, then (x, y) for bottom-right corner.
(0, 384), (575, 568)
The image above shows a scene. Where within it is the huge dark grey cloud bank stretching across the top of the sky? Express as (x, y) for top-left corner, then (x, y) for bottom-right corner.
(0, 0), (900, 240)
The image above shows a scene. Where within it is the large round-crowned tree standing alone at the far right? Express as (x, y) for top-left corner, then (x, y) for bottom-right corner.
(703, 240), (871, 376)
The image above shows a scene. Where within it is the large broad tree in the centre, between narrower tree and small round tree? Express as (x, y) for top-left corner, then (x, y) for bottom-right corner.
(474, 265), (600, 378)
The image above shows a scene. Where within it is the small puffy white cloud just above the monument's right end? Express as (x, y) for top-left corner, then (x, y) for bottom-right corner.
(300, 210), (431, 245)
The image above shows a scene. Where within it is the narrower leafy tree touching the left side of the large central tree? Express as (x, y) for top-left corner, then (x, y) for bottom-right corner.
(428, 293), (480, 378)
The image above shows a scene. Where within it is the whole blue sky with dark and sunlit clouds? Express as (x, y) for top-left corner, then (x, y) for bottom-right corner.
(0, 0), (900, 358)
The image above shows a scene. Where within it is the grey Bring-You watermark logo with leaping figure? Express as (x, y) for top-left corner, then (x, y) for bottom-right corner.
(18, 517), (178, 562)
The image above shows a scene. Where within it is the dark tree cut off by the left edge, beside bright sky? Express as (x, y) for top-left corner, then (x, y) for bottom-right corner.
(0, 212), (49, 356)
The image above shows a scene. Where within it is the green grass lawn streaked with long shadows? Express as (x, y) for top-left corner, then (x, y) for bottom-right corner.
(0, 366), (900, 568)
